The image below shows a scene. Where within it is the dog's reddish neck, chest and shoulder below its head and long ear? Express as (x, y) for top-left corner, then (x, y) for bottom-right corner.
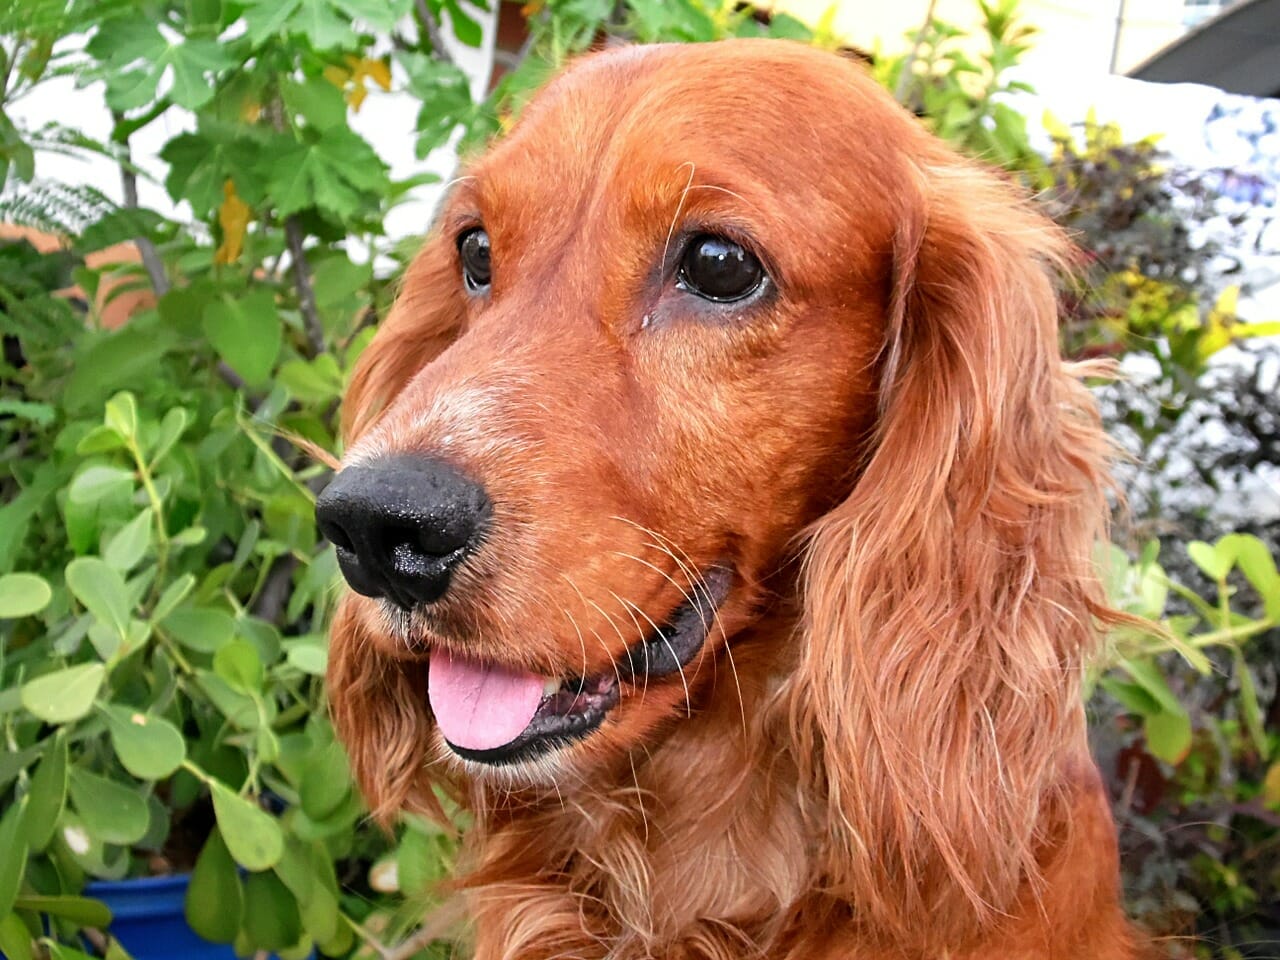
(448, 609), (1133, 960)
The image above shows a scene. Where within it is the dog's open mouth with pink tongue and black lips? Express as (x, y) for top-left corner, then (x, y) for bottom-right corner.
(428, 566), (732, 764)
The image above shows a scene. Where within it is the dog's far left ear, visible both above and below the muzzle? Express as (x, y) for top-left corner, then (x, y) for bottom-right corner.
(326, 237), (463, 822)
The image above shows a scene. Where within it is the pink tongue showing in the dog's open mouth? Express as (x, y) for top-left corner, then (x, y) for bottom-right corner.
(426, 653), (544, 750)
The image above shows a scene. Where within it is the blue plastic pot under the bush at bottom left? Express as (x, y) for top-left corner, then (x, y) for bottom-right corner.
(84, 873), (309, 960)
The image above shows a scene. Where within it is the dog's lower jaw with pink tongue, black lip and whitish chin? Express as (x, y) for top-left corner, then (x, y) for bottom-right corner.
(428, 566), (733, 786)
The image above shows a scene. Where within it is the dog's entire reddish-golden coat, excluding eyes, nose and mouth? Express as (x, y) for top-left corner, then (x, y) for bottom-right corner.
(329, 41), (1143, 960)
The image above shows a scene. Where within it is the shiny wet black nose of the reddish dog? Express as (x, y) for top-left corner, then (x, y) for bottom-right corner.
(316, 454), (493, 609)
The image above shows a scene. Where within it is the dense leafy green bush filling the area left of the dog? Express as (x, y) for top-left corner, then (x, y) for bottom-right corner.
(0, 0), (804, 957)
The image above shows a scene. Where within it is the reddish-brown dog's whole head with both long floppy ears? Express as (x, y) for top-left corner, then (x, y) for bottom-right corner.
(319, 41), (1101, 936)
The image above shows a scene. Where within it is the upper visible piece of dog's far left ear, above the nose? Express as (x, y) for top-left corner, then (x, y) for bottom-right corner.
(342, 234), (463, 445)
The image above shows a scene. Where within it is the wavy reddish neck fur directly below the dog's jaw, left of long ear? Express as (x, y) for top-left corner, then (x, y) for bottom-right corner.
(453, 617), (810, 960)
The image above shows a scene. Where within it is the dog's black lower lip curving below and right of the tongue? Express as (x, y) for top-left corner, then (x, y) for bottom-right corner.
(445, 564), (733, 765)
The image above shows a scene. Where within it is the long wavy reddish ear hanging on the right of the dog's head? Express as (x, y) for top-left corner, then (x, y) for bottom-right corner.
(786, 159), (1107, 956)
